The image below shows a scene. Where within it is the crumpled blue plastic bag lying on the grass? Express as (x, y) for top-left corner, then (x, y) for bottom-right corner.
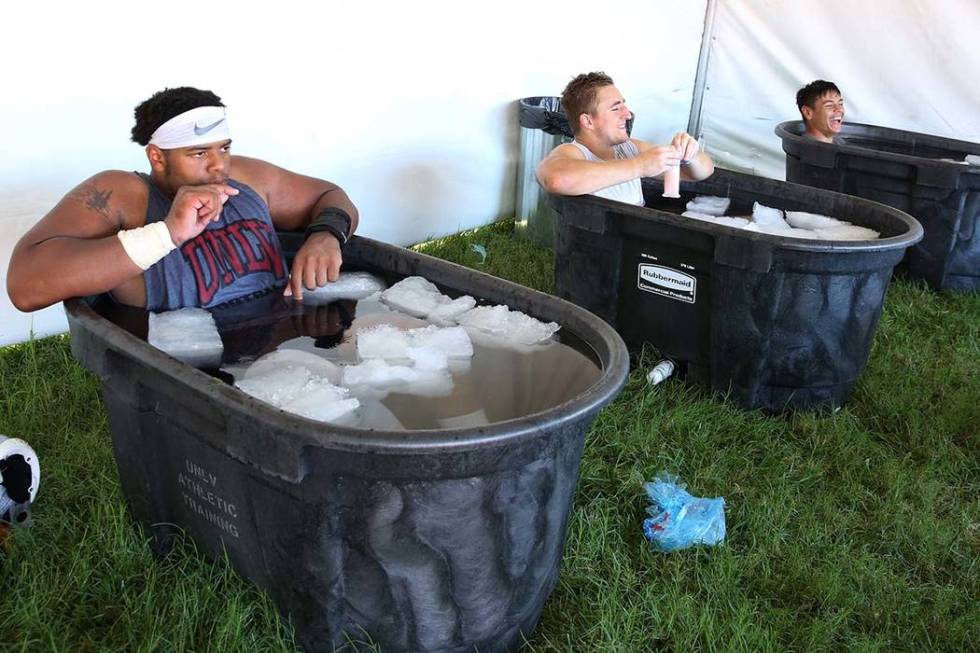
(643, 472), (725, 551)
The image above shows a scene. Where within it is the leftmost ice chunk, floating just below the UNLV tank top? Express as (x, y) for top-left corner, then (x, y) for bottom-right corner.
(146, 308), (224, 367)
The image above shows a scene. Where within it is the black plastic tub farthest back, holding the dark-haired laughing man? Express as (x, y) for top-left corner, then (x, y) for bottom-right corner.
(776, 120), (980, 290)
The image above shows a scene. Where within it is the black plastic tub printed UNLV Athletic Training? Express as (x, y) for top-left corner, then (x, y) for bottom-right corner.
(66, 235), (629, 651)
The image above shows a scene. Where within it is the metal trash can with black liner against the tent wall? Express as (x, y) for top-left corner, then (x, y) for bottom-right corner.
(515, 96), (572, 247)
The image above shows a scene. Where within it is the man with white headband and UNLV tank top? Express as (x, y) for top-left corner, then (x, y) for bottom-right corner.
(7, 87), (358, 311)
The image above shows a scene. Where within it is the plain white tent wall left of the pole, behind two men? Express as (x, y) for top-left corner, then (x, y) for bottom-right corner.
(0, 0), (706, 344)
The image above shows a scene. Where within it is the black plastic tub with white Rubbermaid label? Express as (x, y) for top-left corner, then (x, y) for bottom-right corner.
(552, 169), (922, 412)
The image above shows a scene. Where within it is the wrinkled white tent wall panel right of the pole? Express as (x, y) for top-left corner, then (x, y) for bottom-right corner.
(700, 0), (980, 179)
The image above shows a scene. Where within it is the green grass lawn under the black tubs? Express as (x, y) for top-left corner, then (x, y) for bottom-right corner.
(0, 223), (980, 651)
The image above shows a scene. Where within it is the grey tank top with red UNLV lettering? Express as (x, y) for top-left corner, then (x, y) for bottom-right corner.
(136, 172), (288, 311)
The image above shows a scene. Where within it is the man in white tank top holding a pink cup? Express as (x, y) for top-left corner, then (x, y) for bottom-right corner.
(538, 73), (715, 206)
